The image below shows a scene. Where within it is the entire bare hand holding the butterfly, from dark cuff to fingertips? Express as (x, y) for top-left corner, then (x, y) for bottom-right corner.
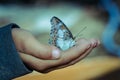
(12, 28), (100, 72)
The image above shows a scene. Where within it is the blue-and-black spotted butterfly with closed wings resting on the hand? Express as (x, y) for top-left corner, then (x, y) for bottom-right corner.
(49, 16), (75, 51)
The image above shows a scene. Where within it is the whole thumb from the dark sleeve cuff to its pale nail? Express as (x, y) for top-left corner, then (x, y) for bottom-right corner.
(12, 28), (60, 59)
